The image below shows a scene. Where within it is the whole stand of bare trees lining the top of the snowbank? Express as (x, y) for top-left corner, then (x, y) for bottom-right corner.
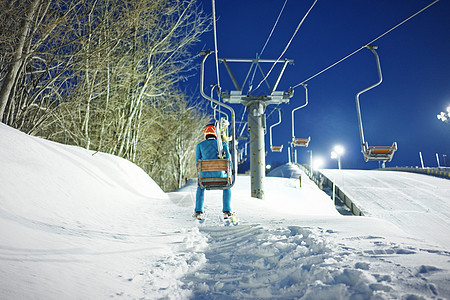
(0, 0), (210, 191)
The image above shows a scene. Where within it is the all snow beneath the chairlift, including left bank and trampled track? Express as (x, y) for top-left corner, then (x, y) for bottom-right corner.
(0, 124), (450, 299)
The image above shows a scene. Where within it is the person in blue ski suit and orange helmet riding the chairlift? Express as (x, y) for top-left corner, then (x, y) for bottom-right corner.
(194, 125), (232, 219)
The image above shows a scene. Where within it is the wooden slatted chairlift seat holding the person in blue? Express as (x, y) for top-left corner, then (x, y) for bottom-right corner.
(197, 159), (232, 190)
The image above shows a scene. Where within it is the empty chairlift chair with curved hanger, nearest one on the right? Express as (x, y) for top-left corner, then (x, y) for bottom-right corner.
(356, 45), (397, 168)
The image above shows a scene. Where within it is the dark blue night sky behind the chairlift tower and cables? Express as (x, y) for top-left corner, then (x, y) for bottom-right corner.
(187, 0), (450, 169)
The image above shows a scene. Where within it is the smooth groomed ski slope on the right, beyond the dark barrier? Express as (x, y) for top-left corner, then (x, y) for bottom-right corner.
(322, 170), (450, 249)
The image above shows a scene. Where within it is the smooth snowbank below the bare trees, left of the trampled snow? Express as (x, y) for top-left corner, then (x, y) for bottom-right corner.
(0, 124), (201, 299)
